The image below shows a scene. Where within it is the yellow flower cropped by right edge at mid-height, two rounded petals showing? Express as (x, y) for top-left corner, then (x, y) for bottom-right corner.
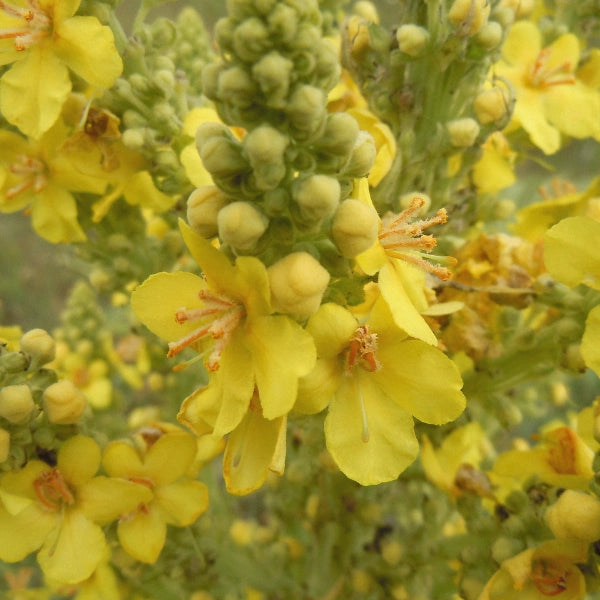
(544, 217), (600, 373)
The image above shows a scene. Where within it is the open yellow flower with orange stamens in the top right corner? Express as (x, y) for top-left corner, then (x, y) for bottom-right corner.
(493, 21), (600, 154)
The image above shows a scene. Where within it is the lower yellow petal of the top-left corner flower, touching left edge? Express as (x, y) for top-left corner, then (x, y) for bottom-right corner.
(0, 46), (71, 138)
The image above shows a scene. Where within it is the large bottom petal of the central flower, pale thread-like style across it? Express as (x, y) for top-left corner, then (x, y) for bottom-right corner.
(325, 369), (419, 485)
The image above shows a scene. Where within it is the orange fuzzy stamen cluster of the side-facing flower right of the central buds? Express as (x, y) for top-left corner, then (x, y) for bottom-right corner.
(379, 196), (456, 281)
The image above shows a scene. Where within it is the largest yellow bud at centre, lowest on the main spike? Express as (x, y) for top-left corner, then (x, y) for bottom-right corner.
(267, 252), (329, 318)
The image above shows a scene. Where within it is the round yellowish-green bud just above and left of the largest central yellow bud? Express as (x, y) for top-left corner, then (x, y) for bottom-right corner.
(217, 202), (269, 250)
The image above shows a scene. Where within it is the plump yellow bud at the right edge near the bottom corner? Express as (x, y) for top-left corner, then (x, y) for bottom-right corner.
(544, 490), (600, 543)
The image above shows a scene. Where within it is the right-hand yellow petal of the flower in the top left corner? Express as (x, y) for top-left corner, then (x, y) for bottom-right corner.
(52, 17), (123, 89)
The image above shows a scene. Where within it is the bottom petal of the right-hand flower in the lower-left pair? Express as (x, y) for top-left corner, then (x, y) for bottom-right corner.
(117, 508), (167, 564)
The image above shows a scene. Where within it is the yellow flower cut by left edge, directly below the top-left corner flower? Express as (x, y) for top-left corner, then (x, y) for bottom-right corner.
(0, 121), (106, 243)
